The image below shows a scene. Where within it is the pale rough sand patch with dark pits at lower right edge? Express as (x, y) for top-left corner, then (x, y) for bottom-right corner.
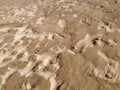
(94, 51), (120, 82)
